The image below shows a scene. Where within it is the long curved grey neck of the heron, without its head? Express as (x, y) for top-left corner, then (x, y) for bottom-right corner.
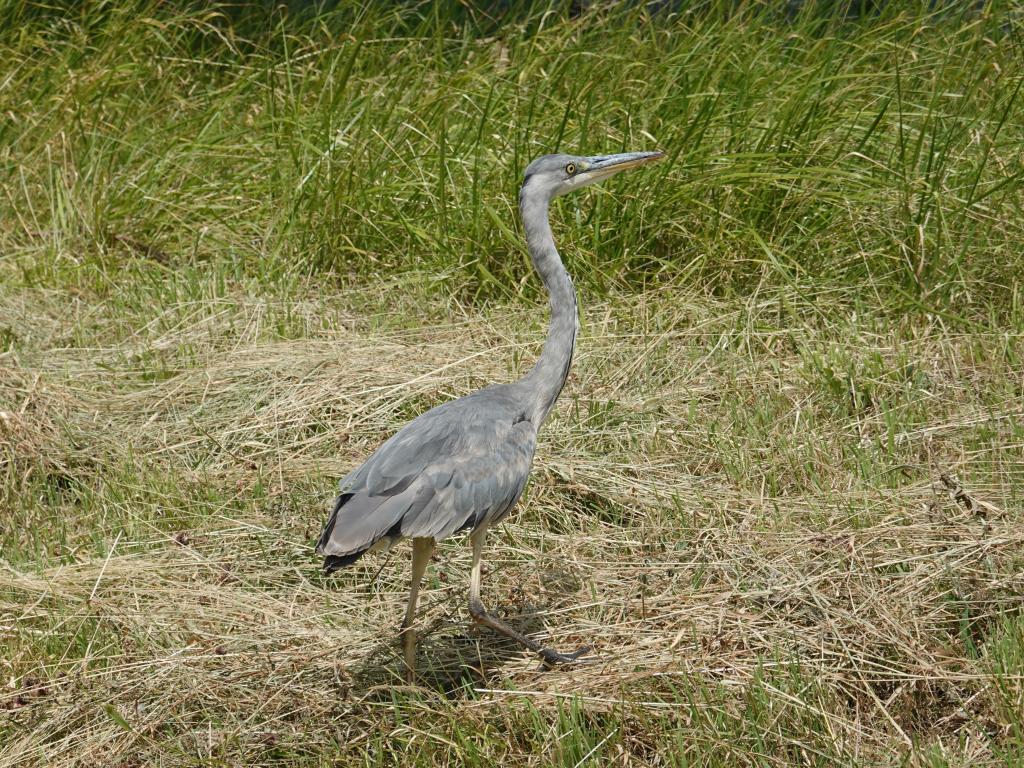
(519, 183), (579, 428)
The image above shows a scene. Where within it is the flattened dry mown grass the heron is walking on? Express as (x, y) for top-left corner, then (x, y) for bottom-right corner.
(0, 286), (1024, 765)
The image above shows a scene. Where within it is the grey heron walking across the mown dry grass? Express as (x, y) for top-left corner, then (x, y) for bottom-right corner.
(316, 152), (665, 679)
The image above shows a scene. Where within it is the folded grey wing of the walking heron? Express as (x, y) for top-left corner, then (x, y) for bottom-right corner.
(316, 398), (537, 568)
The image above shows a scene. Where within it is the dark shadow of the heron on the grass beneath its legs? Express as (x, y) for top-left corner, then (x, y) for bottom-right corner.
(347, 568), (580, 700)
